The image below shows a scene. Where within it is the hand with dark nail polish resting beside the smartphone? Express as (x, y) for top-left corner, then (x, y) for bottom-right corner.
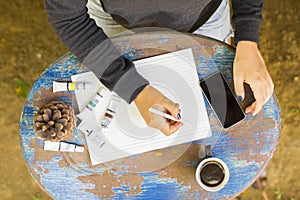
(233, 41), (274, 116)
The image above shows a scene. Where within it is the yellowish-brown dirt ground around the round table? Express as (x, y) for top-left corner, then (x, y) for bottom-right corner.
(0, 0), (300, 200)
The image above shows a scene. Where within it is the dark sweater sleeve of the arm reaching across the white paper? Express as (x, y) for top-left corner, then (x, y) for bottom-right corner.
(45, 0), (149, 103)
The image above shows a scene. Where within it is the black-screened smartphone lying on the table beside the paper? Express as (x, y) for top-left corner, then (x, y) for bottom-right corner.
(200, 72), (245, 129)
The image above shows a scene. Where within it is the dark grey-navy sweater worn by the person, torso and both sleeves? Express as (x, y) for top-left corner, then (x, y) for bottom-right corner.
(45, 0), (263, 103)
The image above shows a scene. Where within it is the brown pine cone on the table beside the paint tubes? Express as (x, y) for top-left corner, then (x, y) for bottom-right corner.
(34, 101), (75, 141)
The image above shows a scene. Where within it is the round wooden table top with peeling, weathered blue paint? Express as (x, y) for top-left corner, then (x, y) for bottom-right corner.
(20, 32), (280, 200)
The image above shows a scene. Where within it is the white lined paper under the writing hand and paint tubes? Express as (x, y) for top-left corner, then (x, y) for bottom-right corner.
(72, 49), (211, 165)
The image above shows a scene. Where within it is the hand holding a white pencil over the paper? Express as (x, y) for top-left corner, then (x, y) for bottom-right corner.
(134, 85), (182, 136)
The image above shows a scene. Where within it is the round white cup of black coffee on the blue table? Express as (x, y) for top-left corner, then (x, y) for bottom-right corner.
(195, 157), (229, 192)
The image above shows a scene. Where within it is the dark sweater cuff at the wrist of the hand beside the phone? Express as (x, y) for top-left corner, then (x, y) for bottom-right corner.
(234, 20), (261, 45)
